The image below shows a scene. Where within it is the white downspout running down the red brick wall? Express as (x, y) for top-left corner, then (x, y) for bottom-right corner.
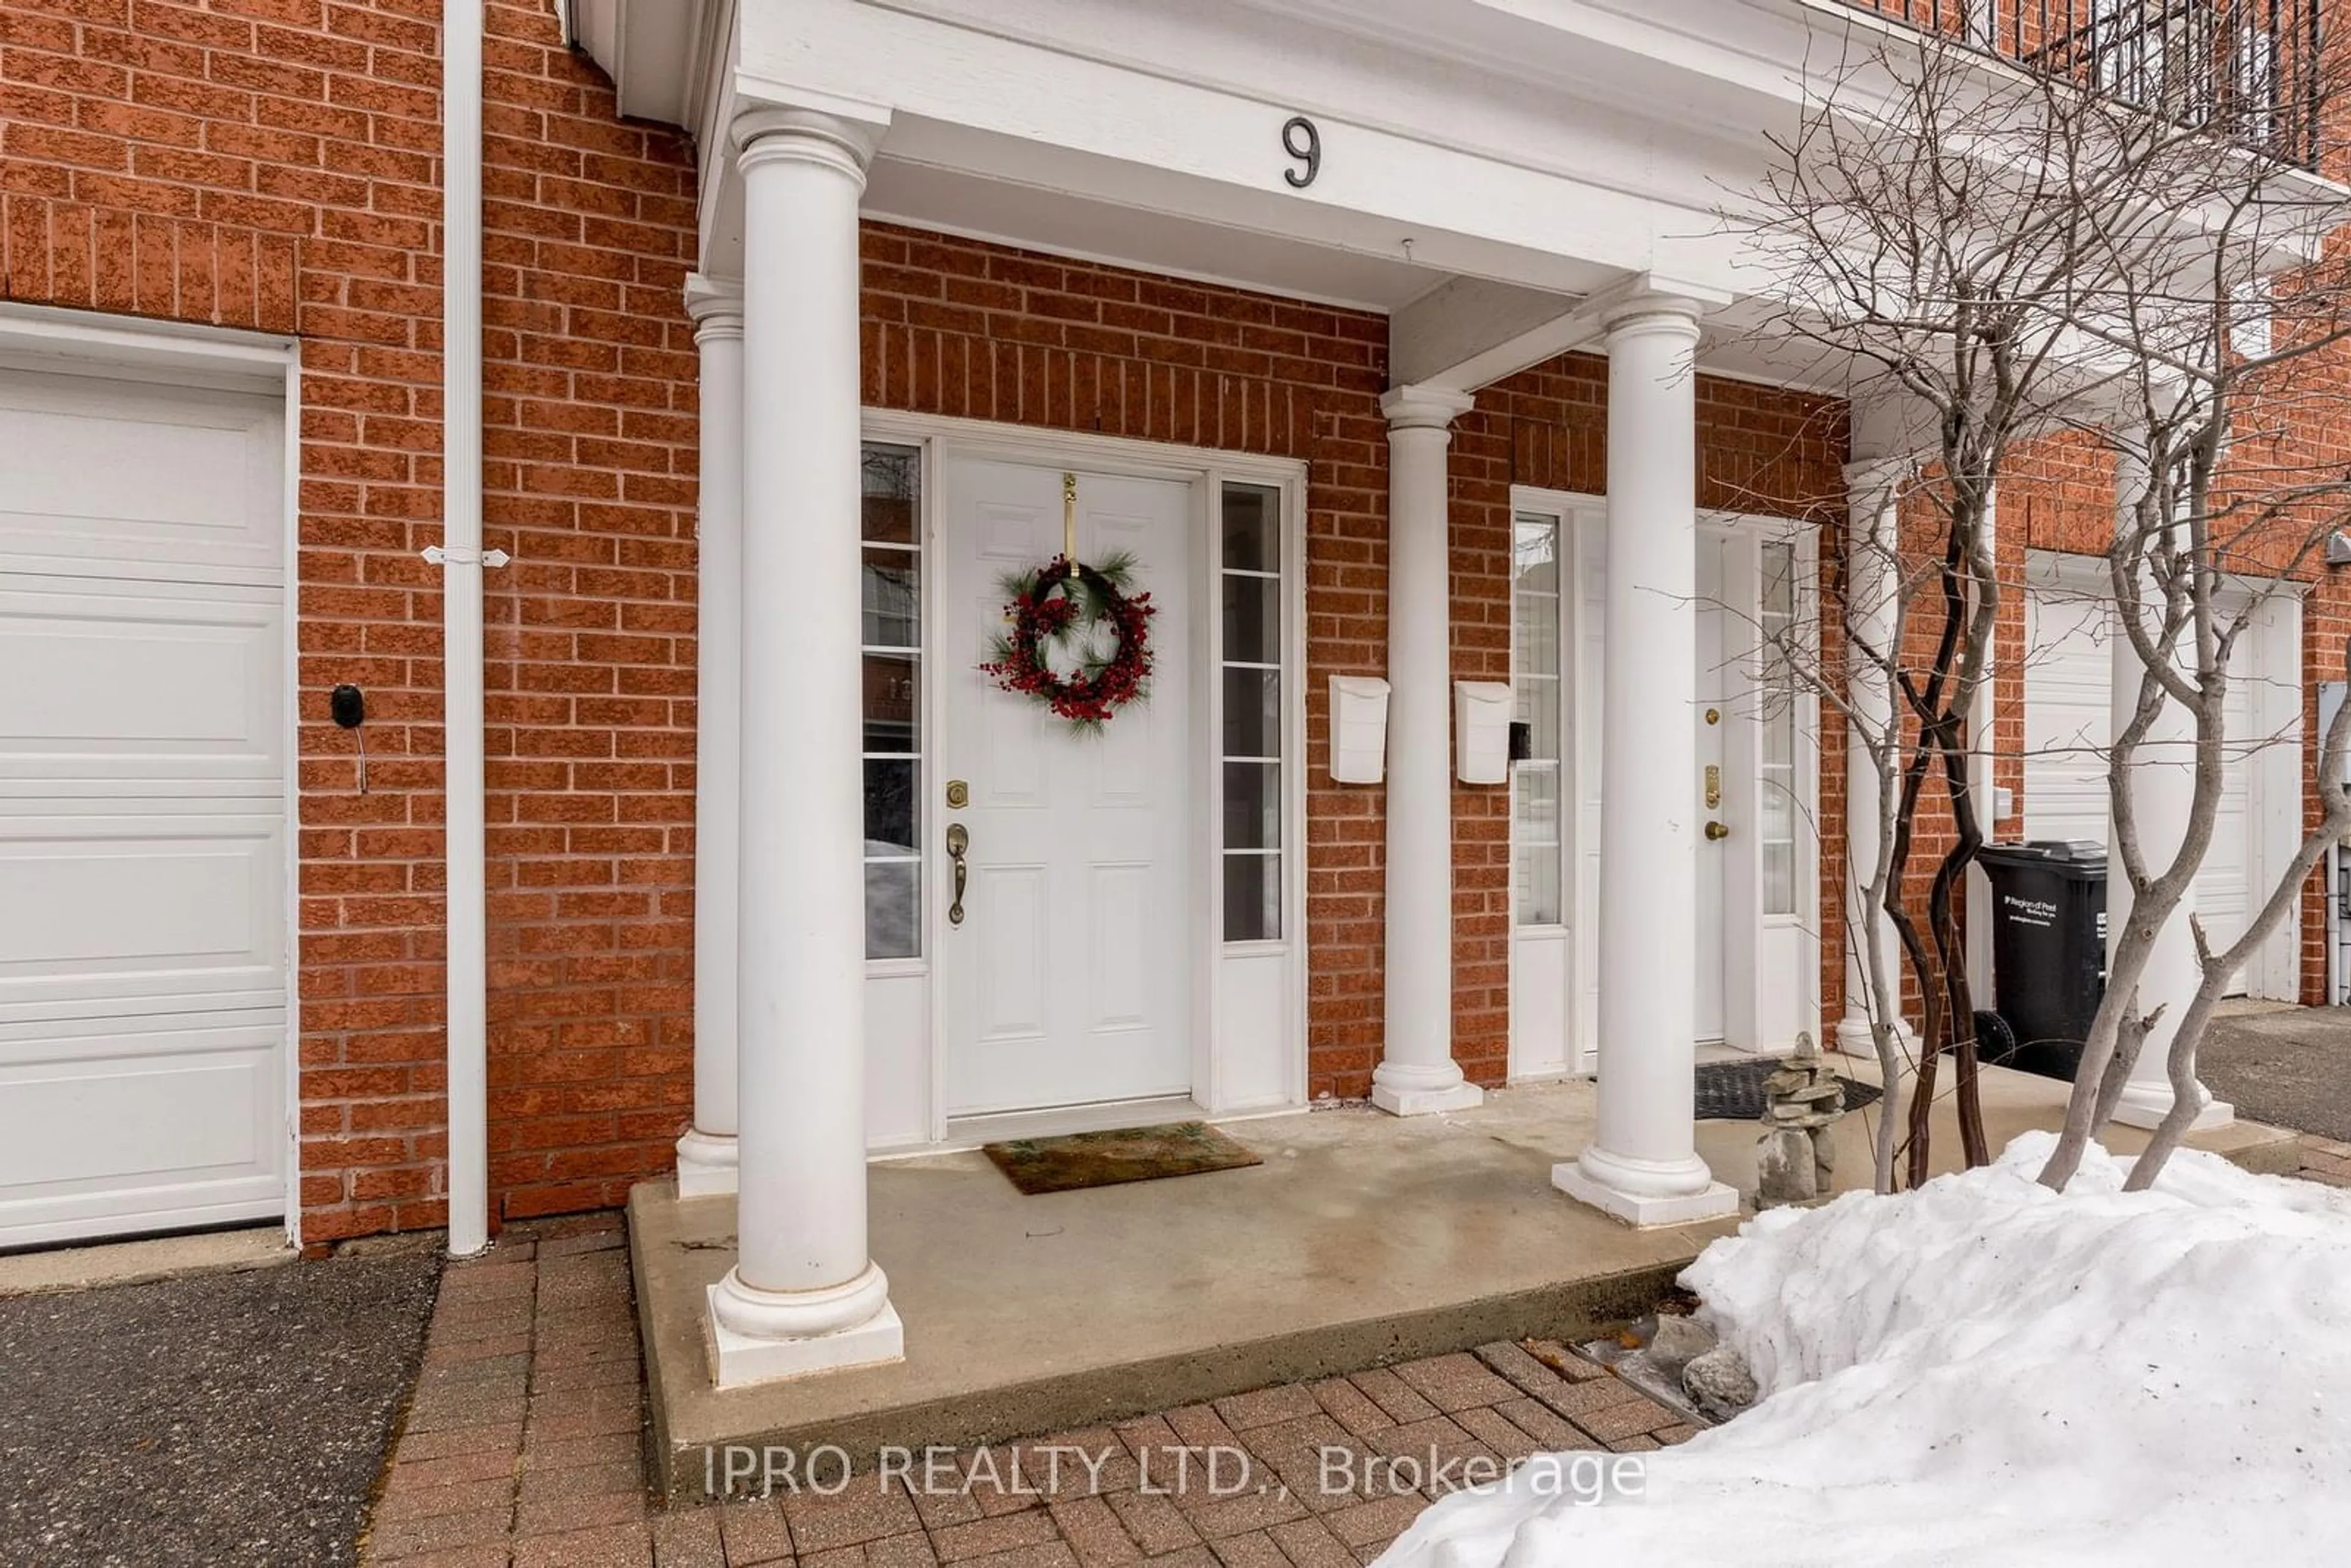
(441, 0), (506, 1258)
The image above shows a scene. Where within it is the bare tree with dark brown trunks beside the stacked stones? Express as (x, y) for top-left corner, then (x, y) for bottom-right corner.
(1728, 36), (2116, 1187)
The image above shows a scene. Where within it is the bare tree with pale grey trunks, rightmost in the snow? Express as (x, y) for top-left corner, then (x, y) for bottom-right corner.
(2041, 49), (2351, 1187)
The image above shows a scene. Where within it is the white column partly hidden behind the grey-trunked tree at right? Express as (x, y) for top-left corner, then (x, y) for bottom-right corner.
(2107, 454), (2236, 1128)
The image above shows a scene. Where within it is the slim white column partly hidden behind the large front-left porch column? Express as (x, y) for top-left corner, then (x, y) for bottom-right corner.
(677, 272), (743, 1196)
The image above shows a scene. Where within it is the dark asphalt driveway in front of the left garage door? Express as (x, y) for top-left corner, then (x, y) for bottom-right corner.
(0, 1251), (440, 1568)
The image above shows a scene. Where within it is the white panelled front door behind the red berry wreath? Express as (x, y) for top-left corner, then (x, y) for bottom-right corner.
(926, 459), (1204, 1117)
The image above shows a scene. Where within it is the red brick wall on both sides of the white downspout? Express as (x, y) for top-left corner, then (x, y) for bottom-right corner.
(0, 0), (694, 1241)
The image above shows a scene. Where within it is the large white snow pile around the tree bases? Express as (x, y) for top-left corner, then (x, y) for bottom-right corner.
(1380, 1133), (2351, 1568)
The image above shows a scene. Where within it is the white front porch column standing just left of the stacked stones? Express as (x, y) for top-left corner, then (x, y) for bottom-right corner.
(1551, 296), (1740, 1225)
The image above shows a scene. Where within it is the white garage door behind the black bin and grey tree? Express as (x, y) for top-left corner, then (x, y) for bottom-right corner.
(2024, 564), (2295, 992)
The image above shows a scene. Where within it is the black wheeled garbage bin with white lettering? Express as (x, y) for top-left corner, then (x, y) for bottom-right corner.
(1975, 839), (2107, 1081)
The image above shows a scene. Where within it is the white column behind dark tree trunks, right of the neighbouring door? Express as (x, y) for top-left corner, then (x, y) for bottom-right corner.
(1836, 459), (1911, 1060)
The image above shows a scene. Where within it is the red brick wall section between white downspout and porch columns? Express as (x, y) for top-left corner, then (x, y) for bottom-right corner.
(472, 0), (700, 1218)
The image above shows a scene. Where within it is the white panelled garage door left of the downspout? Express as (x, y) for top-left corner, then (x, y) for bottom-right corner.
(0, 367), (287, 1246)
